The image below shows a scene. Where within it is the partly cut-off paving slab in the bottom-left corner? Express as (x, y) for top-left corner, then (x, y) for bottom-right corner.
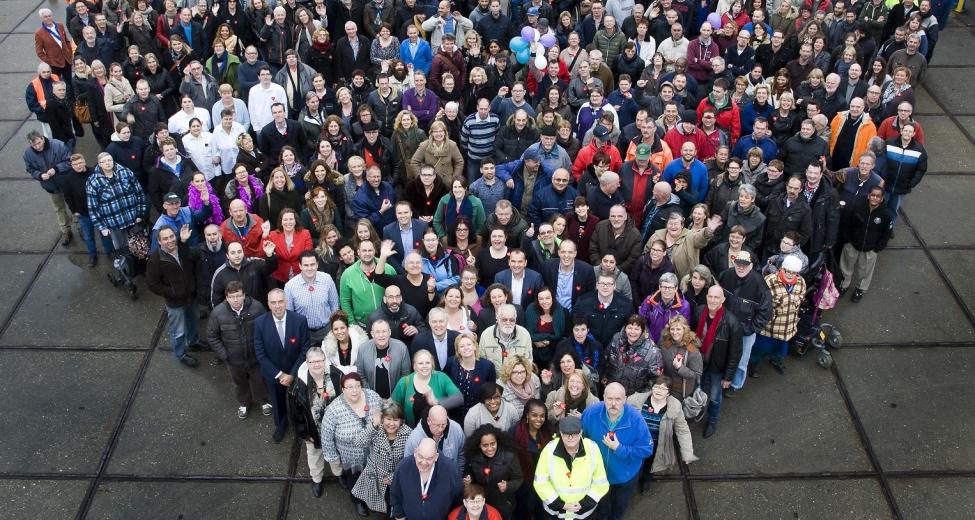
(0, 480), (88, 520)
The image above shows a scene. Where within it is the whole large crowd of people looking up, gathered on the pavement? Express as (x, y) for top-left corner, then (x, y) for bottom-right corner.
(24, 0), (949, 520)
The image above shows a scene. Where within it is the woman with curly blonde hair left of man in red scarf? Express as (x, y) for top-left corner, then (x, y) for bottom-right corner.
(660, 316), (704, 400)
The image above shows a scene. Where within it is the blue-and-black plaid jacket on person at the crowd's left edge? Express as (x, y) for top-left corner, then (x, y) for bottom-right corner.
(85, 164), (149, 230)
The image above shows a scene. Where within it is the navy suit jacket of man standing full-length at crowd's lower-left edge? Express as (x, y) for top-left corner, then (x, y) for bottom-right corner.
(254, 311), (311, 380)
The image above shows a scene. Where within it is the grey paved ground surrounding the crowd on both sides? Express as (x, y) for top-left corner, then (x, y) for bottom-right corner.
(0, 0), (975, 520)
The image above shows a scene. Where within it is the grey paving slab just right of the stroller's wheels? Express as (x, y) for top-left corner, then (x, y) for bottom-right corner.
(822, 249), (973, 343)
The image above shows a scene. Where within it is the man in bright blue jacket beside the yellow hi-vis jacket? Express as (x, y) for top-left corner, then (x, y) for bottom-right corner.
(582, 383), (653, 520)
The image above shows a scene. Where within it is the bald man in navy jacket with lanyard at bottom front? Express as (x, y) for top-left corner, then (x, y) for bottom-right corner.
(389, 434), (463, 520)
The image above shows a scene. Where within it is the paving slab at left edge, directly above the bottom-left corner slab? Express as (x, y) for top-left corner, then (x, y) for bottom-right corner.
(0, 350), (142, 474)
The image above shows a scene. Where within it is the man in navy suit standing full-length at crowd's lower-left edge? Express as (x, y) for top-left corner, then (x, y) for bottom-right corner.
(254, 289), (311, 442)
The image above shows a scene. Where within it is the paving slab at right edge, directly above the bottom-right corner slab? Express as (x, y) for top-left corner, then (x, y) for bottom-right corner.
(836, 347), (975, 471)
